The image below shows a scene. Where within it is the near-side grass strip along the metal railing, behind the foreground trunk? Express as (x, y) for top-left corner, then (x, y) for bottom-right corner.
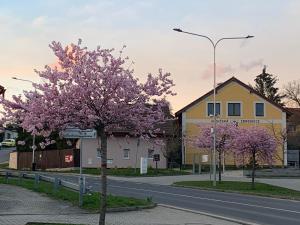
(0, 177), (153, 211)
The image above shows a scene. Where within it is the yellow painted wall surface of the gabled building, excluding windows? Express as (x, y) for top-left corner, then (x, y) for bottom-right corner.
(182, 81), (286, 165)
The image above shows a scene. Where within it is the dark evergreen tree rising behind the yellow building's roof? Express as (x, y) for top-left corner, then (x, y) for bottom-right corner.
(254, 66), (284, 105)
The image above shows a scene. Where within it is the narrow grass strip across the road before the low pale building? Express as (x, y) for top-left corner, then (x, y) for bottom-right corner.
(61, 168), (191, 177)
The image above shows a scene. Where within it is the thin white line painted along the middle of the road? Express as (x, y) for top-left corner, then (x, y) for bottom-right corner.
(109, 185), (300, 214)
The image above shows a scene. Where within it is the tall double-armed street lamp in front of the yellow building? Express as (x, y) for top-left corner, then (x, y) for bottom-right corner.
(173, 28), (254, 186)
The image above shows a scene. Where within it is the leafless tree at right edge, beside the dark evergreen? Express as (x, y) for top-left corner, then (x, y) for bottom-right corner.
(283, 80), (300, 107)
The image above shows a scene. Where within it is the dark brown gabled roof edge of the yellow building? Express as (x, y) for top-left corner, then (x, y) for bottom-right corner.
(175, 77), (290, 116)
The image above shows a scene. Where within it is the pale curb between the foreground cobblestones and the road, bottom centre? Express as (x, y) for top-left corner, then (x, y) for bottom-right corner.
(158, 204), (260, 225)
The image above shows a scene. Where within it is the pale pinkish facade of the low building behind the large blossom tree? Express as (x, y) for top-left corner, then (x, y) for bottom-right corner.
(81, 136), (167, 168)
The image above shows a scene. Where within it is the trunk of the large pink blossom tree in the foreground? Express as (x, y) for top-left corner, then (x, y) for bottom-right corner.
(99, 128), (107, 225)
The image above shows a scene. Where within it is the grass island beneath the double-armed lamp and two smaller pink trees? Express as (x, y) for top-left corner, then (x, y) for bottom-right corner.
(173, 181), (300, 200)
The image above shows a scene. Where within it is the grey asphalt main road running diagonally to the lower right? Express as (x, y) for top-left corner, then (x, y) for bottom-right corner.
(48, 174), (300, 225)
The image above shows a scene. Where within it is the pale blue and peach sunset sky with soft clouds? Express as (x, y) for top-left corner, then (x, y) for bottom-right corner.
(0, 0), (300, 112)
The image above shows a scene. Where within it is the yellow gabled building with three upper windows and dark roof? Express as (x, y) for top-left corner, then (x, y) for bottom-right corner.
(175, 77), (288, 165)
